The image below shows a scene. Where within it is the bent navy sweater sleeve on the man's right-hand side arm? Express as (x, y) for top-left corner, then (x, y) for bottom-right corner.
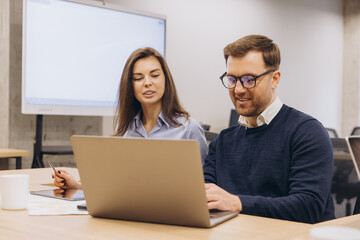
(238, 119), (333, 223)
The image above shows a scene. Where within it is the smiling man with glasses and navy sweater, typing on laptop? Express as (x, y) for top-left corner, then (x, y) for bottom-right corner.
(204, 35), (335, 223)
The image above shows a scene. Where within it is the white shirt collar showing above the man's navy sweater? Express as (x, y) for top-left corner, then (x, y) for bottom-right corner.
(238, 97), (283, 128)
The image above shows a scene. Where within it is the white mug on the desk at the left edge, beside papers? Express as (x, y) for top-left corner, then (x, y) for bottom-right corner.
(0, 174), (29, 210)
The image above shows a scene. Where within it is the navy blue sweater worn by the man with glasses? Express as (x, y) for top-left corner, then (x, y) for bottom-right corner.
(204, 105), (335, 223)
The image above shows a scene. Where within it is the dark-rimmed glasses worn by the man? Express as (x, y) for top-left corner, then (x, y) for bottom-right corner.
(220, 70), (275, 89)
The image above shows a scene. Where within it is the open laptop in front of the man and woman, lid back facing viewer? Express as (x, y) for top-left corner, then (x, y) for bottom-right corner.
(71, 136), (238, 228)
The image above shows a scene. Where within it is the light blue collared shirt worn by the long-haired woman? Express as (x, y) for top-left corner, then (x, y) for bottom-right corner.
(123, 111), (208, 162)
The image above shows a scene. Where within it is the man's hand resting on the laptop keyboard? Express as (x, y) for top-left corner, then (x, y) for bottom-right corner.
(205, 183), (242, 212)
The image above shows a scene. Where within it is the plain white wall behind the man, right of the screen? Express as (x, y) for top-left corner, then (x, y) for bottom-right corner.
(104, 0), (343, 135)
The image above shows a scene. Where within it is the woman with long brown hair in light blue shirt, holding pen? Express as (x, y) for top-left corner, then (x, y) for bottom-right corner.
(53, 48), (207, 189)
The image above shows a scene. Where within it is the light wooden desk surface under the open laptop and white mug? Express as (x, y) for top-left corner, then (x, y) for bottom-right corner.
(0, 168), (360, 240)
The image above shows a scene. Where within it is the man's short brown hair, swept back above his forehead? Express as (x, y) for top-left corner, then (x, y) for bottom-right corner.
(224, 35), (281, 70)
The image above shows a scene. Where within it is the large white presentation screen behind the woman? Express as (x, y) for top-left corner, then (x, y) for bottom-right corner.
(22, 0), (166, 116)
